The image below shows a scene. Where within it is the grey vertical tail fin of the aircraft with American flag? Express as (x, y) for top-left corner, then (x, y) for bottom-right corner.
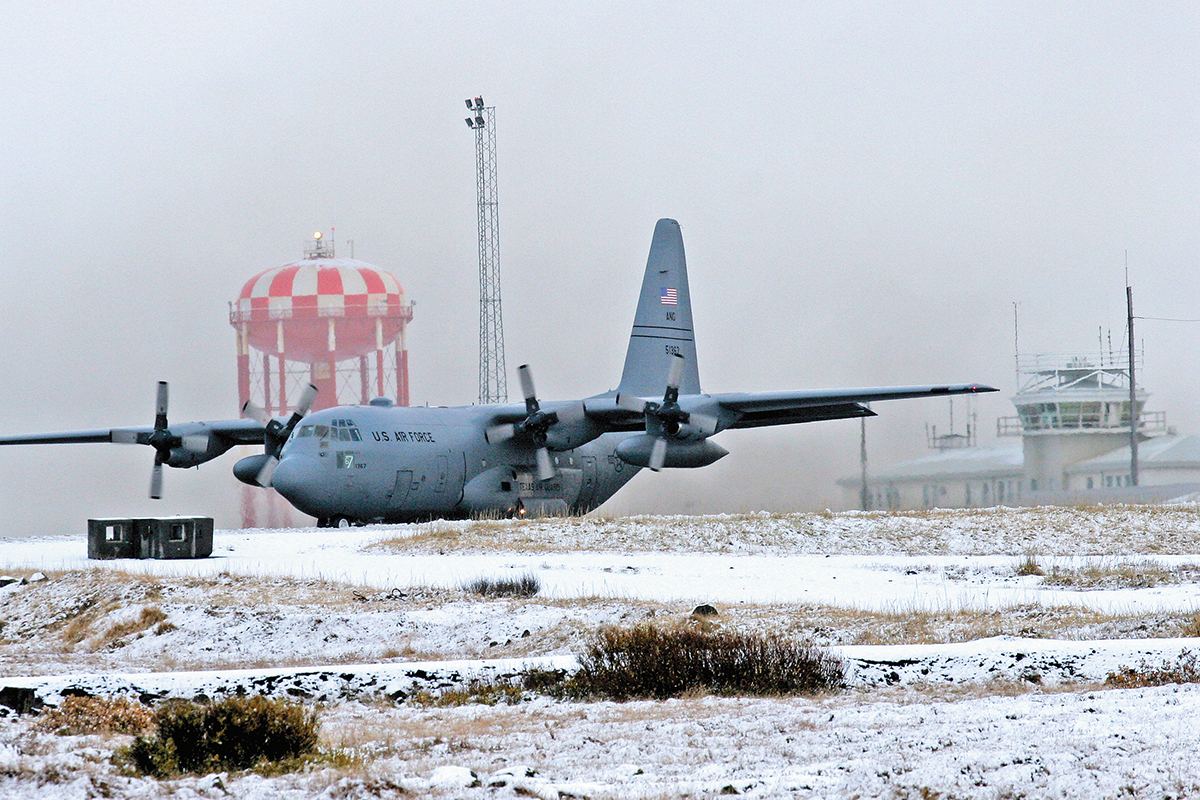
(617, 219), (700, 397)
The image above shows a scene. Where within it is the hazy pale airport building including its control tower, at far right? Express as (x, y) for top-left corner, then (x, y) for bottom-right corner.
(839, 354), (1200, 510)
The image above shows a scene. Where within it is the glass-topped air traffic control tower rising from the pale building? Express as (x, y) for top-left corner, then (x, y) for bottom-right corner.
(996, 353), (1166, 492)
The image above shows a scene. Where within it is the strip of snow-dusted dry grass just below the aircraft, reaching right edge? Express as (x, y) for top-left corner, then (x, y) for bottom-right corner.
(362, 506), (1200, 555)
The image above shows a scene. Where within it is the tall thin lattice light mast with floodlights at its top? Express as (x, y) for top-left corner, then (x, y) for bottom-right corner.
(467, 97), (509, 403)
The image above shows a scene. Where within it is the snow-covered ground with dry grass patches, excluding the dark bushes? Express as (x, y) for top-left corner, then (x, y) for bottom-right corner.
(0, 506), (1200, 798)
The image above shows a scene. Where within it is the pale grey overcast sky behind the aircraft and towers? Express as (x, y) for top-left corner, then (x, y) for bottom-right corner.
(0, 0), (1200, 535)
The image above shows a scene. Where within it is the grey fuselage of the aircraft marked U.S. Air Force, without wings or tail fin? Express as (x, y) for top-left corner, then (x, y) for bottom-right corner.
(272, 405), (638, 524)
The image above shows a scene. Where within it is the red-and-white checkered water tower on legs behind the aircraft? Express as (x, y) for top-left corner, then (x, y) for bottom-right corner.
(229, 231), (413, 527)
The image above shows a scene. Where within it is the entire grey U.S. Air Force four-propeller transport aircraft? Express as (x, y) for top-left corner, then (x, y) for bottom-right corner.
(0, 219), (996, 527)
